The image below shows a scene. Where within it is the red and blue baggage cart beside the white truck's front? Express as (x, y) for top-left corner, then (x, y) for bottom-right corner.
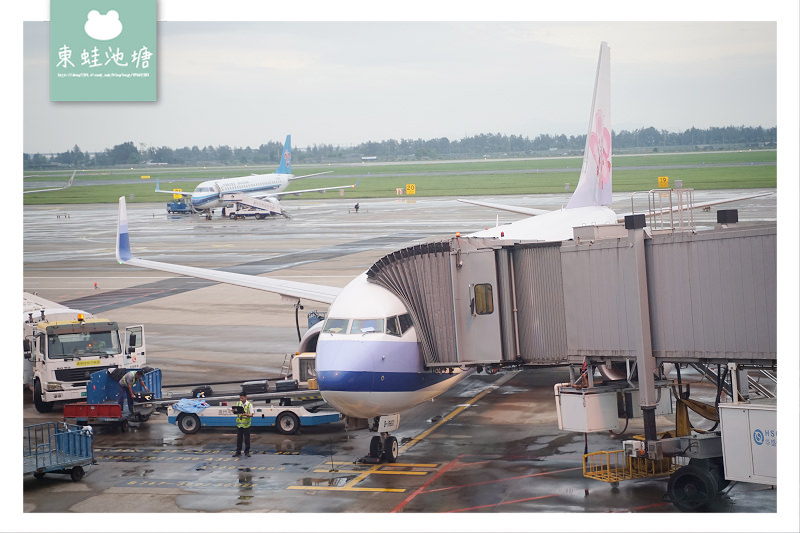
(64, 368), (161, 431)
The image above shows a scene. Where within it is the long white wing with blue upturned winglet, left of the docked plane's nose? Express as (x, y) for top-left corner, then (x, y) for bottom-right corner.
(116, 196), (341, 304)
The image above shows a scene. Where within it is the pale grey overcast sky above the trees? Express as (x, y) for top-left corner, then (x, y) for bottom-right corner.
(23, 21), (778, 153)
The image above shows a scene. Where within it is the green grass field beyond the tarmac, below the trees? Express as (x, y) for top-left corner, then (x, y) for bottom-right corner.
(23, 150), (777, 205)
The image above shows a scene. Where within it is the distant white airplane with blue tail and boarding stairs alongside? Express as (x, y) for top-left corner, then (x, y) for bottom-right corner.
(156, 135), (355, 217)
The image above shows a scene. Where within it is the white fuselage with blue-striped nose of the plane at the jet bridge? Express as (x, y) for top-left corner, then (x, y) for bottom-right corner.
(317, 206), (617, 418)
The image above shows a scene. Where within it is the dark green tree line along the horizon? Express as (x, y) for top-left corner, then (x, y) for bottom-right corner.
(23, 126), (778, 170)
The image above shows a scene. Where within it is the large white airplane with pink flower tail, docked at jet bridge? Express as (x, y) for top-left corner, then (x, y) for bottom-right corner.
(112, 43), (768, 462)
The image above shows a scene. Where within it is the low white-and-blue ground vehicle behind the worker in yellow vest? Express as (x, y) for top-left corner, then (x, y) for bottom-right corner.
(167, 397), (341, 435)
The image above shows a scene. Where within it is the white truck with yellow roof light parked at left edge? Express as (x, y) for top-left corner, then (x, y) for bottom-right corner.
(22, 292), (146, 413)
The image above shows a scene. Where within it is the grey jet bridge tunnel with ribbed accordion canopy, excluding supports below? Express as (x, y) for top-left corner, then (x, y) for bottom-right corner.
(367, 223), (777, 367)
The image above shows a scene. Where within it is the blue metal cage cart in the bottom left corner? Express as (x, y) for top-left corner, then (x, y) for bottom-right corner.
(22, 422), (93, 481)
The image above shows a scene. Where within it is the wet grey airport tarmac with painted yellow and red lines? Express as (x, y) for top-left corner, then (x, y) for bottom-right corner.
(22, 191), (777, 530)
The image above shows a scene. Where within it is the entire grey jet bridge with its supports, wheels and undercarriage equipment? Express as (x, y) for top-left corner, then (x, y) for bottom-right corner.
(367, 202), (780, 510)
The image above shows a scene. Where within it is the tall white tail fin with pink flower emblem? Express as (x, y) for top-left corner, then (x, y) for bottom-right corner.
(567, 41), (611, 209)
